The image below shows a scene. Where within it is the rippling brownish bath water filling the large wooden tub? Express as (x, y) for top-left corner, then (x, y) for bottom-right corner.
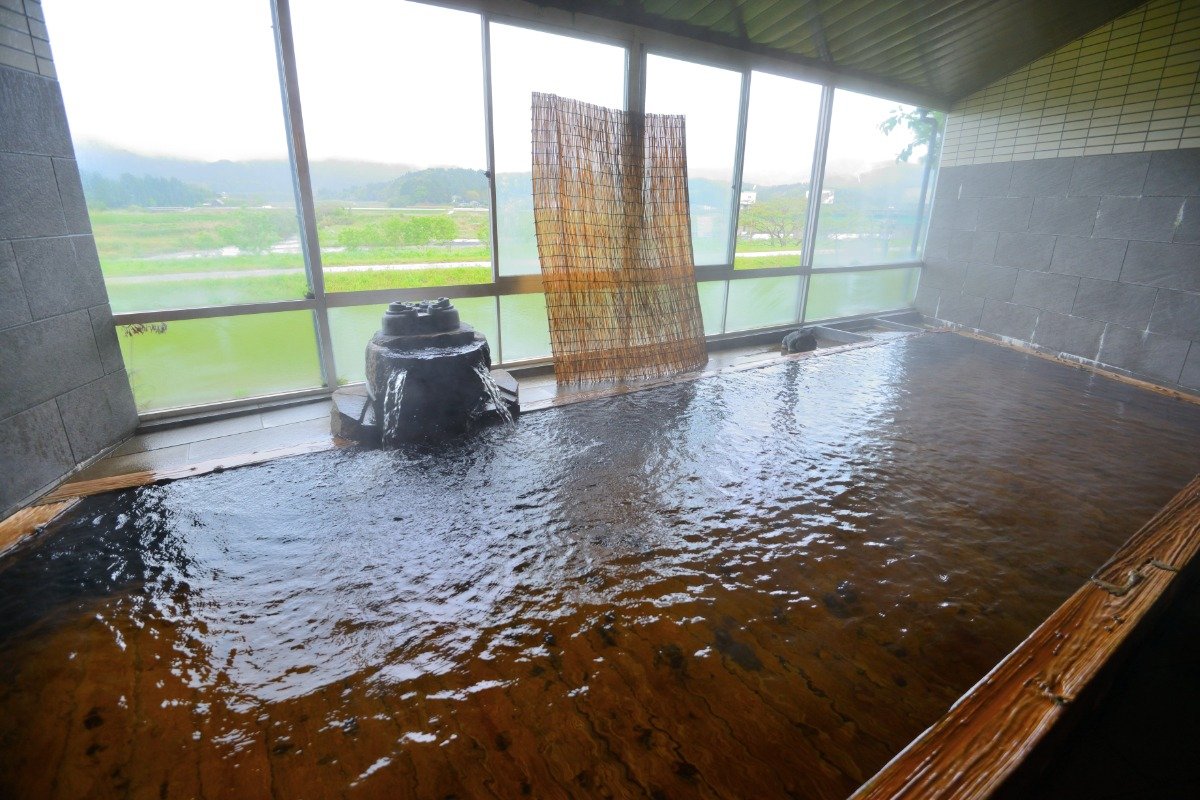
(0, 335), (1200, 798)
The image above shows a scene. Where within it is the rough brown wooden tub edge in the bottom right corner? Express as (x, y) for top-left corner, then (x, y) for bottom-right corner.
(851, 477), (1200, 800)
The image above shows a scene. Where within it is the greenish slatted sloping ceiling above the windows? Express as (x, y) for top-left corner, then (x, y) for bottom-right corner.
(533, 0), (1145, 107)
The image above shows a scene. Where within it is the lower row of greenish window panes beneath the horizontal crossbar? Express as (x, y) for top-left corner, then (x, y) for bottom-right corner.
(119, 270), (916, 410)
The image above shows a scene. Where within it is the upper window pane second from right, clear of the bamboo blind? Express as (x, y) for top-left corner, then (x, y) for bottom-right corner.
(734, 72), (821, 270)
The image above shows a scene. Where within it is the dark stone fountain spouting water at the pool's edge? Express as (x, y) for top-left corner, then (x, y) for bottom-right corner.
(331, 297), (521, 446)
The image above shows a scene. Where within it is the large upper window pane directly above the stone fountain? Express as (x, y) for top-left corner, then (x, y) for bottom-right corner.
(292, 0), (492, 291)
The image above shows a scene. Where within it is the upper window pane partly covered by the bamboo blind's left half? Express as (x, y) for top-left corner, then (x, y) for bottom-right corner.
(491, 24), (625, 277)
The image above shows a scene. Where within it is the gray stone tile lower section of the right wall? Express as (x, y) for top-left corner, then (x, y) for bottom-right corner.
(916, 148), (1200, 393)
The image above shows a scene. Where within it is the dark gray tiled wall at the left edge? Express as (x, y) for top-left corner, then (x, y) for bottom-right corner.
(0, 0), (137, 518)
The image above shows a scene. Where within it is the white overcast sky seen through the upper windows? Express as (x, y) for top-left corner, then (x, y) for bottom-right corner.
(44, 0), (905, 176)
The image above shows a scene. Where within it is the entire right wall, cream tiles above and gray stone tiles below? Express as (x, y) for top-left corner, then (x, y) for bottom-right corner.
(917, 0), (1200, 393)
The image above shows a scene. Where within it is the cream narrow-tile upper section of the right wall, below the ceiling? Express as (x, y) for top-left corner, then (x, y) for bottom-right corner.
(942, 0), (1200, 167)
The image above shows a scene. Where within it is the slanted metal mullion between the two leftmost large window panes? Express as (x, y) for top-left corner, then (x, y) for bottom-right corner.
(271, 0), (337, 387)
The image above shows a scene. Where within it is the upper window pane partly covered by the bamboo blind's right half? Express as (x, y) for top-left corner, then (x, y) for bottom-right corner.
(646, 55), (742, 266)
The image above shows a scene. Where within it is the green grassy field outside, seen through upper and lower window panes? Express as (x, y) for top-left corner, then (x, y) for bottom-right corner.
(100, 206), (916, 410)
